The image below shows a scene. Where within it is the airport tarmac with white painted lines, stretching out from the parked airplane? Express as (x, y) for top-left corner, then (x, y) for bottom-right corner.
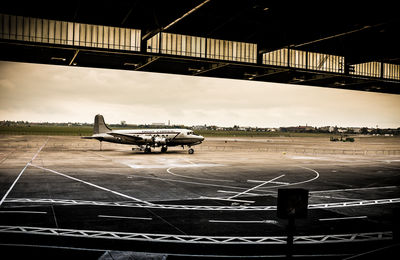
(0, 136), (400, 255)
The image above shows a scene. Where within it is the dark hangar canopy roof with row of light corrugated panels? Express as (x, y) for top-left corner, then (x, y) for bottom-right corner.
(0, 0), (400, 94)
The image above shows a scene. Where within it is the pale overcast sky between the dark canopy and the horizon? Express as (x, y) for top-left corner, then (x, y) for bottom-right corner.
(0, 62), (400, 128)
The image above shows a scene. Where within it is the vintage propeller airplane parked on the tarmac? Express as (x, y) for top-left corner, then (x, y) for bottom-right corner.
(82, 115), (204, 154)
